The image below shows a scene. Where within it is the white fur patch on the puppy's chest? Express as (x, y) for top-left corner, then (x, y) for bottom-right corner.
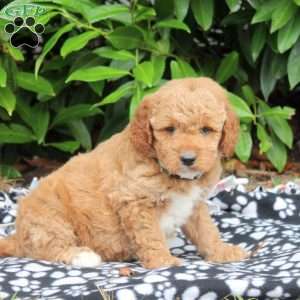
(160, 187), (206, 238)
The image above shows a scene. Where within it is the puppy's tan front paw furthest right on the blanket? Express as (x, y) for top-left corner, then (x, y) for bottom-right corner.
(205, 243), (249, 263)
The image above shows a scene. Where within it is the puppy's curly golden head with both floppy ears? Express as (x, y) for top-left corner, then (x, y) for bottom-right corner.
(130, 78), (239, 179)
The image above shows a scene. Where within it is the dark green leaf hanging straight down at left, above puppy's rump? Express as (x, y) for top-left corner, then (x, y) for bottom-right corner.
(31, 103), (50, 144)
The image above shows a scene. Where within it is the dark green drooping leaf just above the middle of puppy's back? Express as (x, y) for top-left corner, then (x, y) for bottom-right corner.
(68, 120), (92, 150)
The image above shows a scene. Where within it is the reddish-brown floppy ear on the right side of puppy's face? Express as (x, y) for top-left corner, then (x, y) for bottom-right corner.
(220, 98), (240, 157)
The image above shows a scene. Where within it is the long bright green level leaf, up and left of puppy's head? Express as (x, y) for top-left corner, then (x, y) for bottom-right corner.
(66, 66), (129, 82)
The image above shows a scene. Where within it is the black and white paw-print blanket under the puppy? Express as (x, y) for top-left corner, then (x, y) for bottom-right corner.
(0, 179), (300, 300)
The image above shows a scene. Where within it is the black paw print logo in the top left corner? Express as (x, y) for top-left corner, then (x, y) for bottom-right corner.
(4, 17), (45, 48)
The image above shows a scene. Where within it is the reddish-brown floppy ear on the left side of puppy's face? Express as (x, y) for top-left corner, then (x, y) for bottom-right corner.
(130, 96), (155, 157)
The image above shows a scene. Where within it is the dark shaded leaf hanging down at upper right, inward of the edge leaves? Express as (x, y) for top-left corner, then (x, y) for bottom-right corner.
(260, 49), (286, 99)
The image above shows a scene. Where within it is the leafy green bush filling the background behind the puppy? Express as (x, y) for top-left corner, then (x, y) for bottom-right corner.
(0, 0), (300, 178)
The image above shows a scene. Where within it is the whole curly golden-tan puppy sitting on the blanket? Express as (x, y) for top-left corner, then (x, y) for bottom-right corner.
(0, 78), (248, 268)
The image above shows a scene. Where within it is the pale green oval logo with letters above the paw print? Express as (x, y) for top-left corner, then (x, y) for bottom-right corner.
(1, 4), (47, 19)
